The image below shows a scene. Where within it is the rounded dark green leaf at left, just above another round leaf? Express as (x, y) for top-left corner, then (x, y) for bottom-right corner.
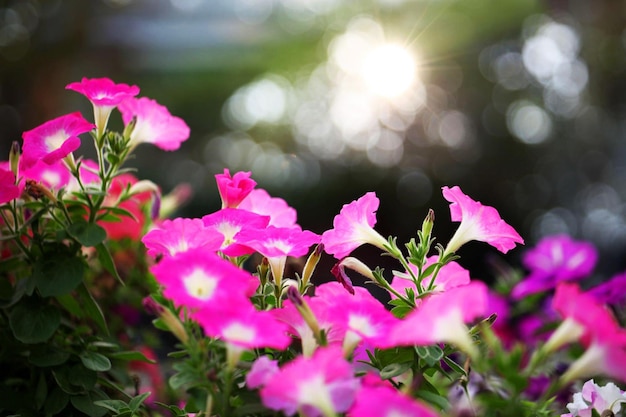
(33, 253), (85, 297)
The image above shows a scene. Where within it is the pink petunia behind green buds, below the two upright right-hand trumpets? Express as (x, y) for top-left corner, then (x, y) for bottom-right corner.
(391, 255), (470, 298)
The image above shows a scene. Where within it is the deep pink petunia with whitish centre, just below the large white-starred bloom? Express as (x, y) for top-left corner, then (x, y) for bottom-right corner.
(192, 302), (291, 350)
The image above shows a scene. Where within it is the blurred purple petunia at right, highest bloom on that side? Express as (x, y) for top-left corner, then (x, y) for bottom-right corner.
(511, 235), (598, 299)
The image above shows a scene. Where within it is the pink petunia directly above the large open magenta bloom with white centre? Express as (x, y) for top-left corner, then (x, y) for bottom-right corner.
(141, 218), (224, 257)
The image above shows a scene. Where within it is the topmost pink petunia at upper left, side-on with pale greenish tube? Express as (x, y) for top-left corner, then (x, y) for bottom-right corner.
(65, 78), (139, 137)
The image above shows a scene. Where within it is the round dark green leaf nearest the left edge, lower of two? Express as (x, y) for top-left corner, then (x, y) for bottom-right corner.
(9, 298), (61, 344)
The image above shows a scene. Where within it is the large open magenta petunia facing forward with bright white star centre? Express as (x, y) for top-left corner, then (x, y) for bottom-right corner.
(150, 248), (259, 309)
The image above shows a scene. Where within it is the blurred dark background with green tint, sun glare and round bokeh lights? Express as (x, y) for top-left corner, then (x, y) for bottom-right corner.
(0, 0), (626, 280)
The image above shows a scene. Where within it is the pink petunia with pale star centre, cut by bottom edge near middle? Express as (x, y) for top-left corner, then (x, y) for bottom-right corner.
(260, 346), (359, 417)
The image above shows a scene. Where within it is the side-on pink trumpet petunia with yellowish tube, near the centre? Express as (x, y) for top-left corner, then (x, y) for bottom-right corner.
(237, 226), (320, 285)
